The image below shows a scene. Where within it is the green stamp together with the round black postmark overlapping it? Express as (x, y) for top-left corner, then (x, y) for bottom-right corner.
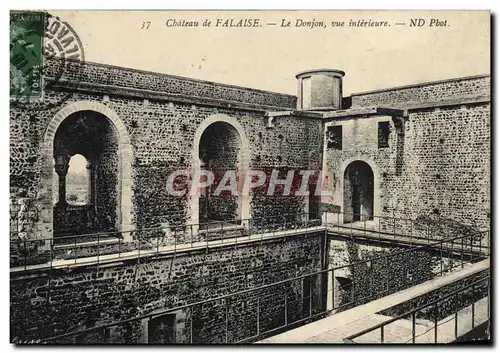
(10, 11), (85, 111)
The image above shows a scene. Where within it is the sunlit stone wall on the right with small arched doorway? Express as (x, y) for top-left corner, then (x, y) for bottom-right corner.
(325, 77), (491, 234)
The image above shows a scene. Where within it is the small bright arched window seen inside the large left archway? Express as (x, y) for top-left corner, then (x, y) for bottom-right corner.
(66, 154), (90, 205)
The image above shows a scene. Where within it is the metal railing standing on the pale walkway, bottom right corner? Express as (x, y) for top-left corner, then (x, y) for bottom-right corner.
(344, 275), (490, 343)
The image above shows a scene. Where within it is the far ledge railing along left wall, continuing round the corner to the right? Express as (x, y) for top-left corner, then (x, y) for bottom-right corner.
(10, 212), (489, 270)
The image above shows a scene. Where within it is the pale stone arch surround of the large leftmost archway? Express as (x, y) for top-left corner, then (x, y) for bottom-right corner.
(38, 101), (133, 238)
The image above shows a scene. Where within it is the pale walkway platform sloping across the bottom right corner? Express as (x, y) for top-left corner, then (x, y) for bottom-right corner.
(257, 259), (490, 343)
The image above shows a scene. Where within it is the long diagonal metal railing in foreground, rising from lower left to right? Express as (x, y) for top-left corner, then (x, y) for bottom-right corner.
(29, 230), (485, 343)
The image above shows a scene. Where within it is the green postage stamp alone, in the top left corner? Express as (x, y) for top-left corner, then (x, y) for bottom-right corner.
(10, 11), (45, 99)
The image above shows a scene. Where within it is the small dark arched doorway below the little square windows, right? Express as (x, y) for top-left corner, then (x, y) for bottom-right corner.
(344, 161), (374, 223)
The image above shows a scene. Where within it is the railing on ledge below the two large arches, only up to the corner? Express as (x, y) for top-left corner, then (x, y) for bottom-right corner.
(10, 213), (324, 270)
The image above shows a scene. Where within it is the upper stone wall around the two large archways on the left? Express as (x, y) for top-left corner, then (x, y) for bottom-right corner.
(10, 86), (322, 238)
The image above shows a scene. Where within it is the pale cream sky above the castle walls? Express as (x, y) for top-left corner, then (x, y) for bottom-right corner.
(50, 11), (490, 96)
